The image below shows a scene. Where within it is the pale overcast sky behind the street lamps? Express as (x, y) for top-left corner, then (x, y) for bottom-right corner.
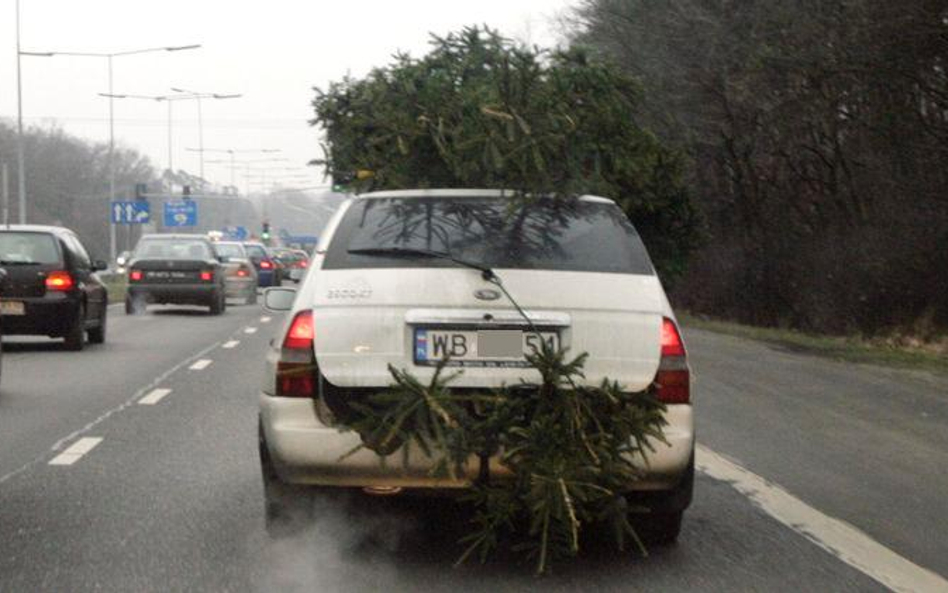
(0, 0), (576, 190)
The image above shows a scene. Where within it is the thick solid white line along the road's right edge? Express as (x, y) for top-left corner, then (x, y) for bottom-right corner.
(695, 445), (948, 591)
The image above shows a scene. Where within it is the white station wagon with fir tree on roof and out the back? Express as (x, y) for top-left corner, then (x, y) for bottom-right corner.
(259, 190), (694, 542)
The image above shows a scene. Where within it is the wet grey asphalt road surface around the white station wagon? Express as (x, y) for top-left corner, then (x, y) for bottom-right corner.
(0, 306), (948, 591)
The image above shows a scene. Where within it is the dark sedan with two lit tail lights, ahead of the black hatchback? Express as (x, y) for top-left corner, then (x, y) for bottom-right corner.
(125, 234), (227, 315)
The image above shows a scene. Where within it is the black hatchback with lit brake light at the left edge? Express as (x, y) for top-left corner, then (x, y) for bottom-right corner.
(0, 225), (108, 350)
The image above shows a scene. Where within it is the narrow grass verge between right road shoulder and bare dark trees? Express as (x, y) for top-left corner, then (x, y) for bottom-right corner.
(678, 313), (948, 375)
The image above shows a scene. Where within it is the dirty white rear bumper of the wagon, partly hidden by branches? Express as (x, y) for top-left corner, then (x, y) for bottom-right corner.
(259, 393), (694, 491)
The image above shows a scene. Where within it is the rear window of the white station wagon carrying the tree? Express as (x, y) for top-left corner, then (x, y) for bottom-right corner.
(323, 197), (654, 275)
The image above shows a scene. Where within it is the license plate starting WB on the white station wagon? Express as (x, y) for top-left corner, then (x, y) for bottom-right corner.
(414, 328), (560, 367)
